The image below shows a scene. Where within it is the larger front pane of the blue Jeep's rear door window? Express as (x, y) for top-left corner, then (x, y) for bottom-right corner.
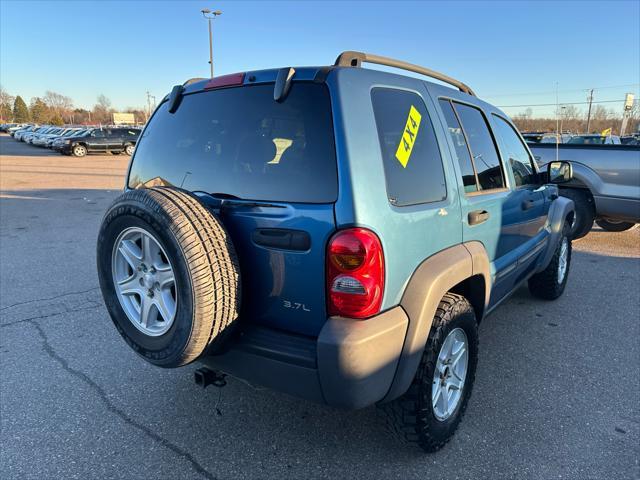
(454, 102), (506, 190)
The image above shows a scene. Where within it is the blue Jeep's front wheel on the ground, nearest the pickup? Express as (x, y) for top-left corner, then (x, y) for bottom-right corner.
(529, 223), (572, 300)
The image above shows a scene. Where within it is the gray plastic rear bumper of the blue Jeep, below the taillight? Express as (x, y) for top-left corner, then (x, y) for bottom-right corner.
(200, 307), (408, 408)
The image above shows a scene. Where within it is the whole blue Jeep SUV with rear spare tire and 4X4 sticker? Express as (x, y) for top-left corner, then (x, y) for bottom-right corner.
(97, 52), (574, 451)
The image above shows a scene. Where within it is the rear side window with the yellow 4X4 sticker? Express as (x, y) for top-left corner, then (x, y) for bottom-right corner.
(371, 88), (447, 206)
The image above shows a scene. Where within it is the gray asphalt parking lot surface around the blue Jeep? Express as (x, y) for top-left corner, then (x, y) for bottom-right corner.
(0, 132), (640, 479)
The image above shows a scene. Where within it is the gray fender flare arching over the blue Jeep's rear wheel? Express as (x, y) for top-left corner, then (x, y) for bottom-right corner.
(382, 242), (491, 402)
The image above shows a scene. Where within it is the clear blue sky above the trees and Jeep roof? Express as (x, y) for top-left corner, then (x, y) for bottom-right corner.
(0, 0), (640, 114)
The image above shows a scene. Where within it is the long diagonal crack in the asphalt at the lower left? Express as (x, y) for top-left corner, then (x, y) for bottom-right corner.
(26, 320), (216, 480)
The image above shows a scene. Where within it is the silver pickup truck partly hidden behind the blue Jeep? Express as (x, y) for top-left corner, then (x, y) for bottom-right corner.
(528, 143), (640, 239)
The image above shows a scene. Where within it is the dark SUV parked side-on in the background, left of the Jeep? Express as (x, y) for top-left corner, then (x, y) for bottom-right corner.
(57, 128), (140, 157)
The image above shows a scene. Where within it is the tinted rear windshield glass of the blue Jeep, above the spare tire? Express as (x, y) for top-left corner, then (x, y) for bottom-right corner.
(129, 82), (338, 203)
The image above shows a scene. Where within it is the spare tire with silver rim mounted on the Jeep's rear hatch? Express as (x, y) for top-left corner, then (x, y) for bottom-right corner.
(97, 187), (240, 367)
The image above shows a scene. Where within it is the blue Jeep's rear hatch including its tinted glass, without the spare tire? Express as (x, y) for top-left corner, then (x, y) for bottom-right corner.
(128, 77), (338, 336)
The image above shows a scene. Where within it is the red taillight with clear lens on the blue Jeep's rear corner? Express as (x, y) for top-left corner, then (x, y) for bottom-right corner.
(327, 228), (384, 318)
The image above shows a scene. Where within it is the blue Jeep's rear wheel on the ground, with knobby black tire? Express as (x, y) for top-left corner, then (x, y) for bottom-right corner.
(381, 293), (478, 452)
